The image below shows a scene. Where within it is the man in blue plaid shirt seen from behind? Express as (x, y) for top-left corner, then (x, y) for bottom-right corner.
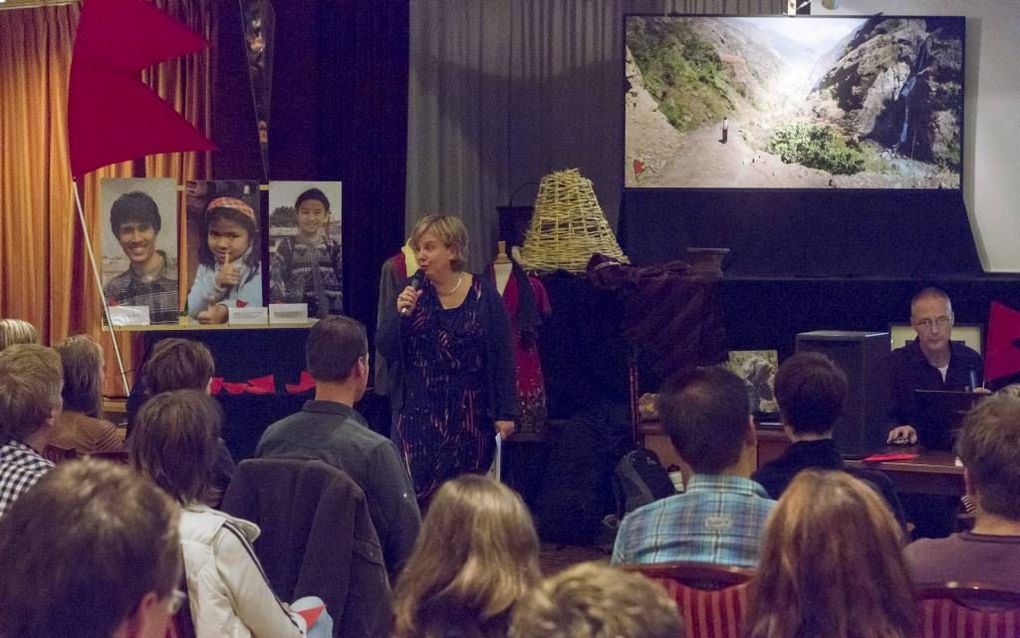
(612, 367), (775, 568)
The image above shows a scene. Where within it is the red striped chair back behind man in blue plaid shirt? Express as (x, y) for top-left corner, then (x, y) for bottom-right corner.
(620, 562), (754, 638)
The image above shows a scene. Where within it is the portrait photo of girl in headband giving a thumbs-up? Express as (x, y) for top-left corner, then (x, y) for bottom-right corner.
(188, 183), (262, 324)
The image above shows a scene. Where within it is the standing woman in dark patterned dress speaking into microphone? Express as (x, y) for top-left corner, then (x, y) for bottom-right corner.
(376, 215), (518, 505)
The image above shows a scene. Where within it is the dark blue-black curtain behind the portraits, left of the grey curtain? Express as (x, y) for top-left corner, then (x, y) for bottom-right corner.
(213, 0), (410, 337)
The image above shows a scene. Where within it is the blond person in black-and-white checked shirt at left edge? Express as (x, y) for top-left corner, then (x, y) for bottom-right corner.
(0, 344), (63, 518)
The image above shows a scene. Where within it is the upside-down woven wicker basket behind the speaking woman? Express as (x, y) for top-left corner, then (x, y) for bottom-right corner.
(520, 168), (628, 273)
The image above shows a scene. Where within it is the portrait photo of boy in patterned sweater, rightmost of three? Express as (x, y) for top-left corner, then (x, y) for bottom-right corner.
(269, 182), (344, 318)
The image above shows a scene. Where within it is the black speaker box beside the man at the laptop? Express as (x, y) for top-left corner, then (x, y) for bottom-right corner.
(797, 330), (891, 458)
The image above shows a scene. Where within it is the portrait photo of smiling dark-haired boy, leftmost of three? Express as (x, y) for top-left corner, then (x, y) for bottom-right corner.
(101, 179), (180, 324)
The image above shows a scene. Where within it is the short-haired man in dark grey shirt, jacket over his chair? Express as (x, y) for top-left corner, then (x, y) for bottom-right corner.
(255, 316), (421, 577)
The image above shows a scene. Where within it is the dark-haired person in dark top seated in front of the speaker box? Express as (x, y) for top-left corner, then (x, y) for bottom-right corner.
(751, 352), (905, 525)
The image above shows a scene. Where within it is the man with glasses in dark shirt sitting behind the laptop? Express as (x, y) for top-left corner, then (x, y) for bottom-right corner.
(888, 288), (982, 445)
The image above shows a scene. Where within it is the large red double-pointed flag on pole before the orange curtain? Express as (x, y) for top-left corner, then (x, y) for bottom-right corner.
(67, 0), (215, 177)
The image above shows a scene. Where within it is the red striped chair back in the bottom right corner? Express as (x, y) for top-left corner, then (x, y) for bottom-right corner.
(917, 583), (1020, 638)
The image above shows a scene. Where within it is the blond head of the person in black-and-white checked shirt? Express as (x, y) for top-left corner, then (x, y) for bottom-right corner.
(0, 343), (63, 445)
